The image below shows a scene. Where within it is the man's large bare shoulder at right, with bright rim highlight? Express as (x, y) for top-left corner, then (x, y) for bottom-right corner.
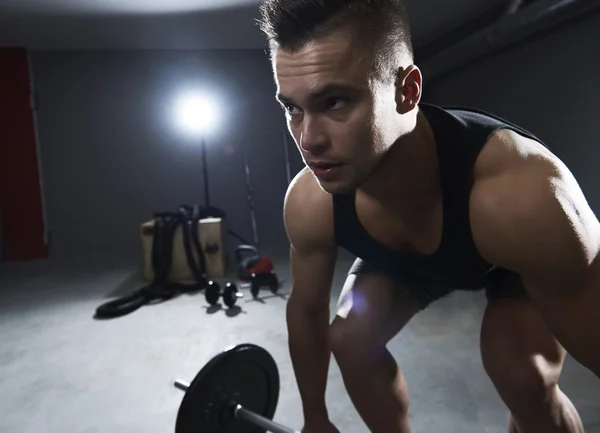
(470, 130), (597, 267)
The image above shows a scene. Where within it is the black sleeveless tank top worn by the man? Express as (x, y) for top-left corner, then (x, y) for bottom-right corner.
(333, 103), (543, 290)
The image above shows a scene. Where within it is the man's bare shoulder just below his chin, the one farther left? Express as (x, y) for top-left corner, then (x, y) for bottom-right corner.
(284, 168), (334, 249)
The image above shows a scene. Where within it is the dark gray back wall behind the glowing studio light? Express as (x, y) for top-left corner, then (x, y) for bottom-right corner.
(32, 51), (287, 258)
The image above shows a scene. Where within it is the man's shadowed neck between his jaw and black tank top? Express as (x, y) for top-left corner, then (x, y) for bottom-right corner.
(359, 111), (439, 206)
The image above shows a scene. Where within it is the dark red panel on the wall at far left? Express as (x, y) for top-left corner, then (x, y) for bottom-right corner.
(0, 48), (48, 261)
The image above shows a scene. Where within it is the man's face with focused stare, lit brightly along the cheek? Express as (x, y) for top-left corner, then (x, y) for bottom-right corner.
(273, 30), (401, 193)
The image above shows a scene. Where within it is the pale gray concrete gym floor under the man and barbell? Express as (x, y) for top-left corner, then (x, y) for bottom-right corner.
(0, 251), (600, 433)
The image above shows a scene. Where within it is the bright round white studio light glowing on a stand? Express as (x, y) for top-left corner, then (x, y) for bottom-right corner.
(175, 93), (217, 135)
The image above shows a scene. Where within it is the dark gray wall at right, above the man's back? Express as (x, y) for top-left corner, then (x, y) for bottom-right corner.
(424, 13), (600, 214)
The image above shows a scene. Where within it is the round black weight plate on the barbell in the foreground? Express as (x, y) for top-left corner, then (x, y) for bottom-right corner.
(175, 344), (279, 433)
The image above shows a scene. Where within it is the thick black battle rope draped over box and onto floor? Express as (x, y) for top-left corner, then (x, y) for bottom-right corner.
(95, 205), (247, 319)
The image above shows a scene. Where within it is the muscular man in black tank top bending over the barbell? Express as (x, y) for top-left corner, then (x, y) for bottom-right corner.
(261, 0), (600, 433)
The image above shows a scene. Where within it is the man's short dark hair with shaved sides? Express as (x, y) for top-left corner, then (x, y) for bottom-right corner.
(259, 0), (414, 81)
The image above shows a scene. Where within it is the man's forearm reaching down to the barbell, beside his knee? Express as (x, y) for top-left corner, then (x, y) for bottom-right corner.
(287, 302), (331, 423)
